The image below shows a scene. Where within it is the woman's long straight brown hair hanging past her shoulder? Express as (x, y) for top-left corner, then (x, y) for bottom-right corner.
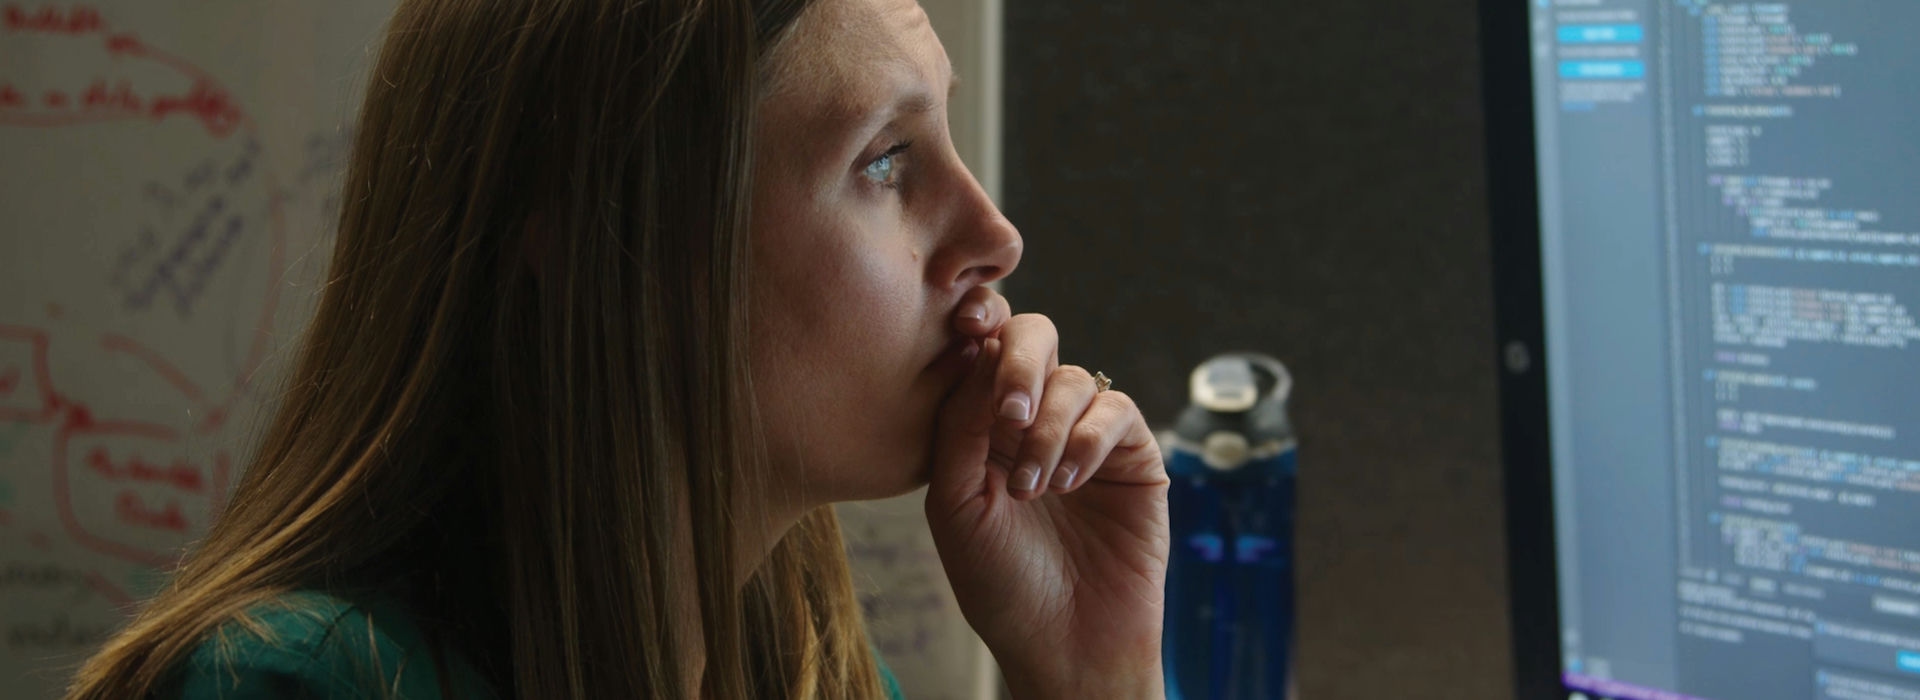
(67, 0), (881, 698)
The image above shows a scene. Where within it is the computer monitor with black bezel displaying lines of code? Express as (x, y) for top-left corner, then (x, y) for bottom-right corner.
(1482, 0), (1920, 700)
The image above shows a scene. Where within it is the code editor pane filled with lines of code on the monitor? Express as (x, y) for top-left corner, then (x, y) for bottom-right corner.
(1661, 0), (1920, 700)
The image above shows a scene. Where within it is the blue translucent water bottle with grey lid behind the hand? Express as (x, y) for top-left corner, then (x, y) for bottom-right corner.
(1158, 353), (1298, 700)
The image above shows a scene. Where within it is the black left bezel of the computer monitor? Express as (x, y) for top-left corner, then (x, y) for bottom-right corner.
(1480, 0), (1567, 700)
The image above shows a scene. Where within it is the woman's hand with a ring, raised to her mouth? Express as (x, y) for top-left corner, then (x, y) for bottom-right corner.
(925, 288), (1169, 698)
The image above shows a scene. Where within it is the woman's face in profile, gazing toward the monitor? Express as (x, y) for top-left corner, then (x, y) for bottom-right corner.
(751, 0), (1021, 506)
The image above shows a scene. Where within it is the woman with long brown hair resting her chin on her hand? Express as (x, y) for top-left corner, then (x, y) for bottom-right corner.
(69, 0), (1167, 698)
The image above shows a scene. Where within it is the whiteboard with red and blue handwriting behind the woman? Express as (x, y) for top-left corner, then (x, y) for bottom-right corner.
(0, 0), (985, 700)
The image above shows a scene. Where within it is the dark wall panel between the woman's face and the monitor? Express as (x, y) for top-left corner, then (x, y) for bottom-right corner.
(1002, 0), (1511, 700)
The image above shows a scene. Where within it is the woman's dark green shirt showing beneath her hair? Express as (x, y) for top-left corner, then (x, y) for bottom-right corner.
(161, 591), (900, 700)
